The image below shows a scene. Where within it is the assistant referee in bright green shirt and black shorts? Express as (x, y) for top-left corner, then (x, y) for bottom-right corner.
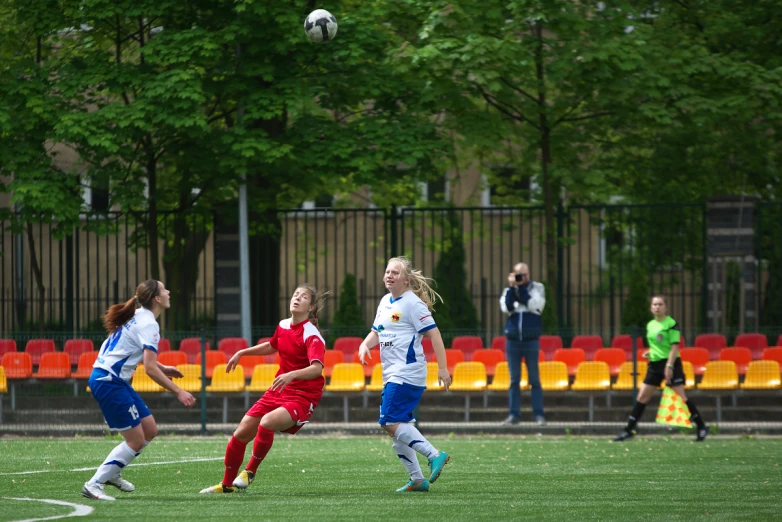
(614, 295), (710, 442)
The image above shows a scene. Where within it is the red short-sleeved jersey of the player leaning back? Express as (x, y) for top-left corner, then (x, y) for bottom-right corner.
(269, 319), (326, 403)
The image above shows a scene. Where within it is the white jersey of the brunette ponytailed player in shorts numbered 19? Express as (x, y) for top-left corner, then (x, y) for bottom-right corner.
(92, 307), (160, 382)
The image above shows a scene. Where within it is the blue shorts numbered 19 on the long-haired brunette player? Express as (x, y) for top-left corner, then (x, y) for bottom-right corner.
(89, 368), (152, 431)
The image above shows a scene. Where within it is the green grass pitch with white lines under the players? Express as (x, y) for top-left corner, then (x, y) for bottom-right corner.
(0, 435), (782, 522)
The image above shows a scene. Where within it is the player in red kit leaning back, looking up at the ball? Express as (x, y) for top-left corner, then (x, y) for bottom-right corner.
(201, 284), (327, 494)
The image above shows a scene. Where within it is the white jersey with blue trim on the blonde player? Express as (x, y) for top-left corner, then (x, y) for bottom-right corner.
(372, 290), (437, 387)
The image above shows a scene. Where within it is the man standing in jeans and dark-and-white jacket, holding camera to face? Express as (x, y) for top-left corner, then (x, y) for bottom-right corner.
(500, 263), (546, 426)
